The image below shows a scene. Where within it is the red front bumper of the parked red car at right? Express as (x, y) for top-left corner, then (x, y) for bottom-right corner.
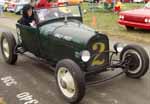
(118, 20), (150, 30)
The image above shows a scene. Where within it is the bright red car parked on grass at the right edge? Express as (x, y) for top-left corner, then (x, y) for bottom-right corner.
(118, 2), (150, 30)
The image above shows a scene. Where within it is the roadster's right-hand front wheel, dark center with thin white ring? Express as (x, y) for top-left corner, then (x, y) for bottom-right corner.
(120, 45), (149, 78)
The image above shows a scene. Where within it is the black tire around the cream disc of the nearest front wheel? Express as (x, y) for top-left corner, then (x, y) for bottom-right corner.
(56, 59), (85, 104)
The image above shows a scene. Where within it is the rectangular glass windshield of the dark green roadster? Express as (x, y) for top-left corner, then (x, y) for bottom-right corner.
(36, 5), (81, 22)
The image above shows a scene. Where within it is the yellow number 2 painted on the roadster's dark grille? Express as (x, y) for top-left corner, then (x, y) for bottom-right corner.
(92, 42), (105, 66)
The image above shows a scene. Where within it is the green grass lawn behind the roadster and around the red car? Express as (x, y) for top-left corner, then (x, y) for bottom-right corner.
(2, 3), (150, 43)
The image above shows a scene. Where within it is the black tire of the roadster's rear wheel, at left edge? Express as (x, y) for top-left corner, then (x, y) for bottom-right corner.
(0, 32), (17, 65)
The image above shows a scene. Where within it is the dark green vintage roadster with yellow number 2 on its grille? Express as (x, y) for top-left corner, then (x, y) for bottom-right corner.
(1, 5), (149, 103)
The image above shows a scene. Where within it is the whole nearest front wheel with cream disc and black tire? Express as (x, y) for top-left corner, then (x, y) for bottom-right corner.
(56, 59), (85, 103)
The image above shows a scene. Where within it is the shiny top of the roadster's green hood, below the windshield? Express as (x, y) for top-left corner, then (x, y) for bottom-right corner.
(40, 21), (96, 45)
